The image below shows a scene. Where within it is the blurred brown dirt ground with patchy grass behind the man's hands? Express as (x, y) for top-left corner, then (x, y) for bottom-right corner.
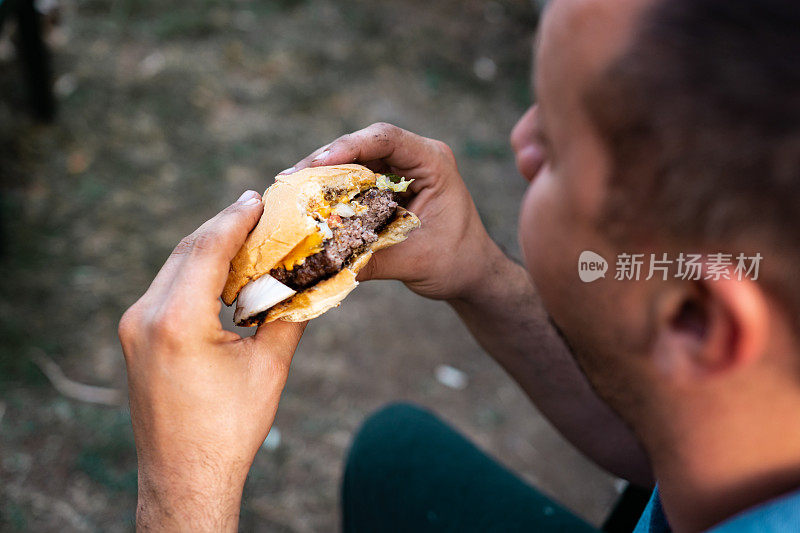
(0, 0), (619, 532)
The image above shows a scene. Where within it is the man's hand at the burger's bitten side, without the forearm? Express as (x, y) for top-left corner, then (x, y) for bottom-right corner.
(284, 123), (507, 300)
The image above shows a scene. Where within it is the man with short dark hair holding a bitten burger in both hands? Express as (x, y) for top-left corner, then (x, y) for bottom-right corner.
(120, 0), (800, 531)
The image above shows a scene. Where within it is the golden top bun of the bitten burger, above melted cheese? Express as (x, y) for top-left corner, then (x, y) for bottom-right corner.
(222, 165), (390, 305)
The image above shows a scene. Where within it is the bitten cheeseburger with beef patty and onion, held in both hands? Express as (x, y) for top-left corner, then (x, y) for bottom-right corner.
(222, 165), (420, 326)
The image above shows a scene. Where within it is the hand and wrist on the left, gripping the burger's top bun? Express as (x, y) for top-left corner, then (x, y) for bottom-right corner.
(119, 191), (305, 531)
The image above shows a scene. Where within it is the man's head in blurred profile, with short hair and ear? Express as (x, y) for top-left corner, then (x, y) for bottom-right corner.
(512, 0), (800, 450)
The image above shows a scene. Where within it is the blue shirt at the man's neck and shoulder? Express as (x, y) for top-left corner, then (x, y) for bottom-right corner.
(633, 487), (800, 533)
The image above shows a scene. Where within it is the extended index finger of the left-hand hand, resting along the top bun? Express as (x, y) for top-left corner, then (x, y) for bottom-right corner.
(170, 191), (264, 302)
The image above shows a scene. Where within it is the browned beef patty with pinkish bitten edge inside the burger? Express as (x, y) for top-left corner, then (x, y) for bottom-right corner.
(269, 187), (397, 292)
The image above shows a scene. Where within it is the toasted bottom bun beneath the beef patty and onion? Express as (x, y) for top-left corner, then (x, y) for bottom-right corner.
(238, 207), (420, 326)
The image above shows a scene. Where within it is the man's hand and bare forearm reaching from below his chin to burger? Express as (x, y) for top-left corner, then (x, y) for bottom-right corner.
(284, 124), (651, 485)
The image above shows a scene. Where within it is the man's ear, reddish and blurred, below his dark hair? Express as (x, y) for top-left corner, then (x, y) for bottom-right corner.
(652, 279), (770, 384)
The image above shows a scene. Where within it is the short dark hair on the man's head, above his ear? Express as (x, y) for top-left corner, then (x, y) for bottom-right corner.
(586, 0), (800, 311)
